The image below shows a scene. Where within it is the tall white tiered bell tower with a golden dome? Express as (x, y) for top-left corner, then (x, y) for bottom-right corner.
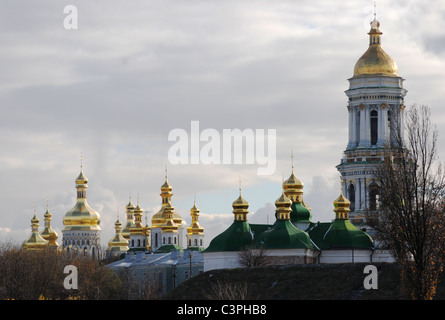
(337, 14), (407, 225)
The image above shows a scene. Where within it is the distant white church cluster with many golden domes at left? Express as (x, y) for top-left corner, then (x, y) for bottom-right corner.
(22, 163), (204, 258)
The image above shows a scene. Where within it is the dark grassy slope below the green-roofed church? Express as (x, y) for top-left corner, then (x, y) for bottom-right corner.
(164, 263), (445, 300)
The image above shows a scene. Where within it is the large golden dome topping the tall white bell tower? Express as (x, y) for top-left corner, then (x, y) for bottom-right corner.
(354, 18), (398, 77)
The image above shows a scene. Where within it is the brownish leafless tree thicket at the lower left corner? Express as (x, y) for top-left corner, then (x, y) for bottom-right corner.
(0, 244), (126, 300)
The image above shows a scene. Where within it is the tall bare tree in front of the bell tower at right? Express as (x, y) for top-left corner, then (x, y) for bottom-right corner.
(367, 105), (445, 300)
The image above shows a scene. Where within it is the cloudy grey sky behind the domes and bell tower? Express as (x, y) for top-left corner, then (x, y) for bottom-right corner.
(0, 0), (445, 246)
